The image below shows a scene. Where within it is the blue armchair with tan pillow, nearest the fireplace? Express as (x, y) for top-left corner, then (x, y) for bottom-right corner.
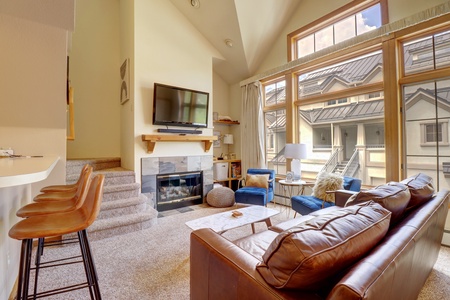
(234, 169), (275, 206)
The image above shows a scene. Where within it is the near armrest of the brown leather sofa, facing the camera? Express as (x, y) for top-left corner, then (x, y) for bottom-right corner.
(190, 228), (320, 300)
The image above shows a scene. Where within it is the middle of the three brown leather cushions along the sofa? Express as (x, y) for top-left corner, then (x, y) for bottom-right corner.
(345, 181), (411, 224)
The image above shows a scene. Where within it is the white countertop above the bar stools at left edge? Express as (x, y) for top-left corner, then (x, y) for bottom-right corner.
(0, 156), (59, 188)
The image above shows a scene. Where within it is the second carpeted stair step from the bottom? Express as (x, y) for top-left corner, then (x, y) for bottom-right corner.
(97, 194), (147, 220)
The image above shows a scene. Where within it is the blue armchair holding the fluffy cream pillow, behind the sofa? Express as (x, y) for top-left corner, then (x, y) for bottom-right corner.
(291, 176), (361, 218)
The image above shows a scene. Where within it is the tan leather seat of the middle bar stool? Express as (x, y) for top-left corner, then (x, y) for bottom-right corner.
(16, 166), (92, 218)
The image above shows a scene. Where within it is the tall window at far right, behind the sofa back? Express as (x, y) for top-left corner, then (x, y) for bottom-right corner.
(402, 31), (450, 189)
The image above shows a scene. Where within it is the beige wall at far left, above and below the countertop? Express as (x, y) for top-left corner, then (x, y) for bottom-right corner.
(0, 1), (74, 299)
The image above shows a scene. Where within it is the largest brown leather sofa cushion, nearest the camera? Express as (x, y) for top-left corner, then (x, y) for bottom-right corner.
(257, 201), (391, 289)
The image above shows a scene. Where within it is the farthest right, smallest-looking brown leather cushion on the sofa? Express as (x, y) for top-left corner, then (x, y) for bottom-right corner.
(401, 173), (434, 208)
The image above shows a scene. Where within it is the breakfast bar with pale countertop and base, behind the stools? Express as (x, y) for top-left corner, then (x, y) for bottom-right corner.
(0, 156), (59, 299)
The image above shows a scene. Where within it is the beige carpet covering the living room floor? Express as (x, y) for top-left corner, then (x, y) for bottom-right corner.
(26, 205), (450, 300)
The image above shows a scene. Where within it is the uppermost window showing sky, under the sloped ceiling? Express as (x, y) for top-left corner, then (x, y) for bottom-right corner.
(288, 1), (385, 59)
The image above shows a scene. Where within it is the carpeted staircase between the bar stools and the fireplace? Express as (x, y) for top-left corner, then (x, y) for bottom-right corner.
(66, 158), (158, 240)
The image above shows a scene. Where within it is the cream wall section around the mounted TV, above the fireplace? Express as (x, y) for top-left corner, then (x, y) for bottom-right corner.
(132, 0), (223, 180)
